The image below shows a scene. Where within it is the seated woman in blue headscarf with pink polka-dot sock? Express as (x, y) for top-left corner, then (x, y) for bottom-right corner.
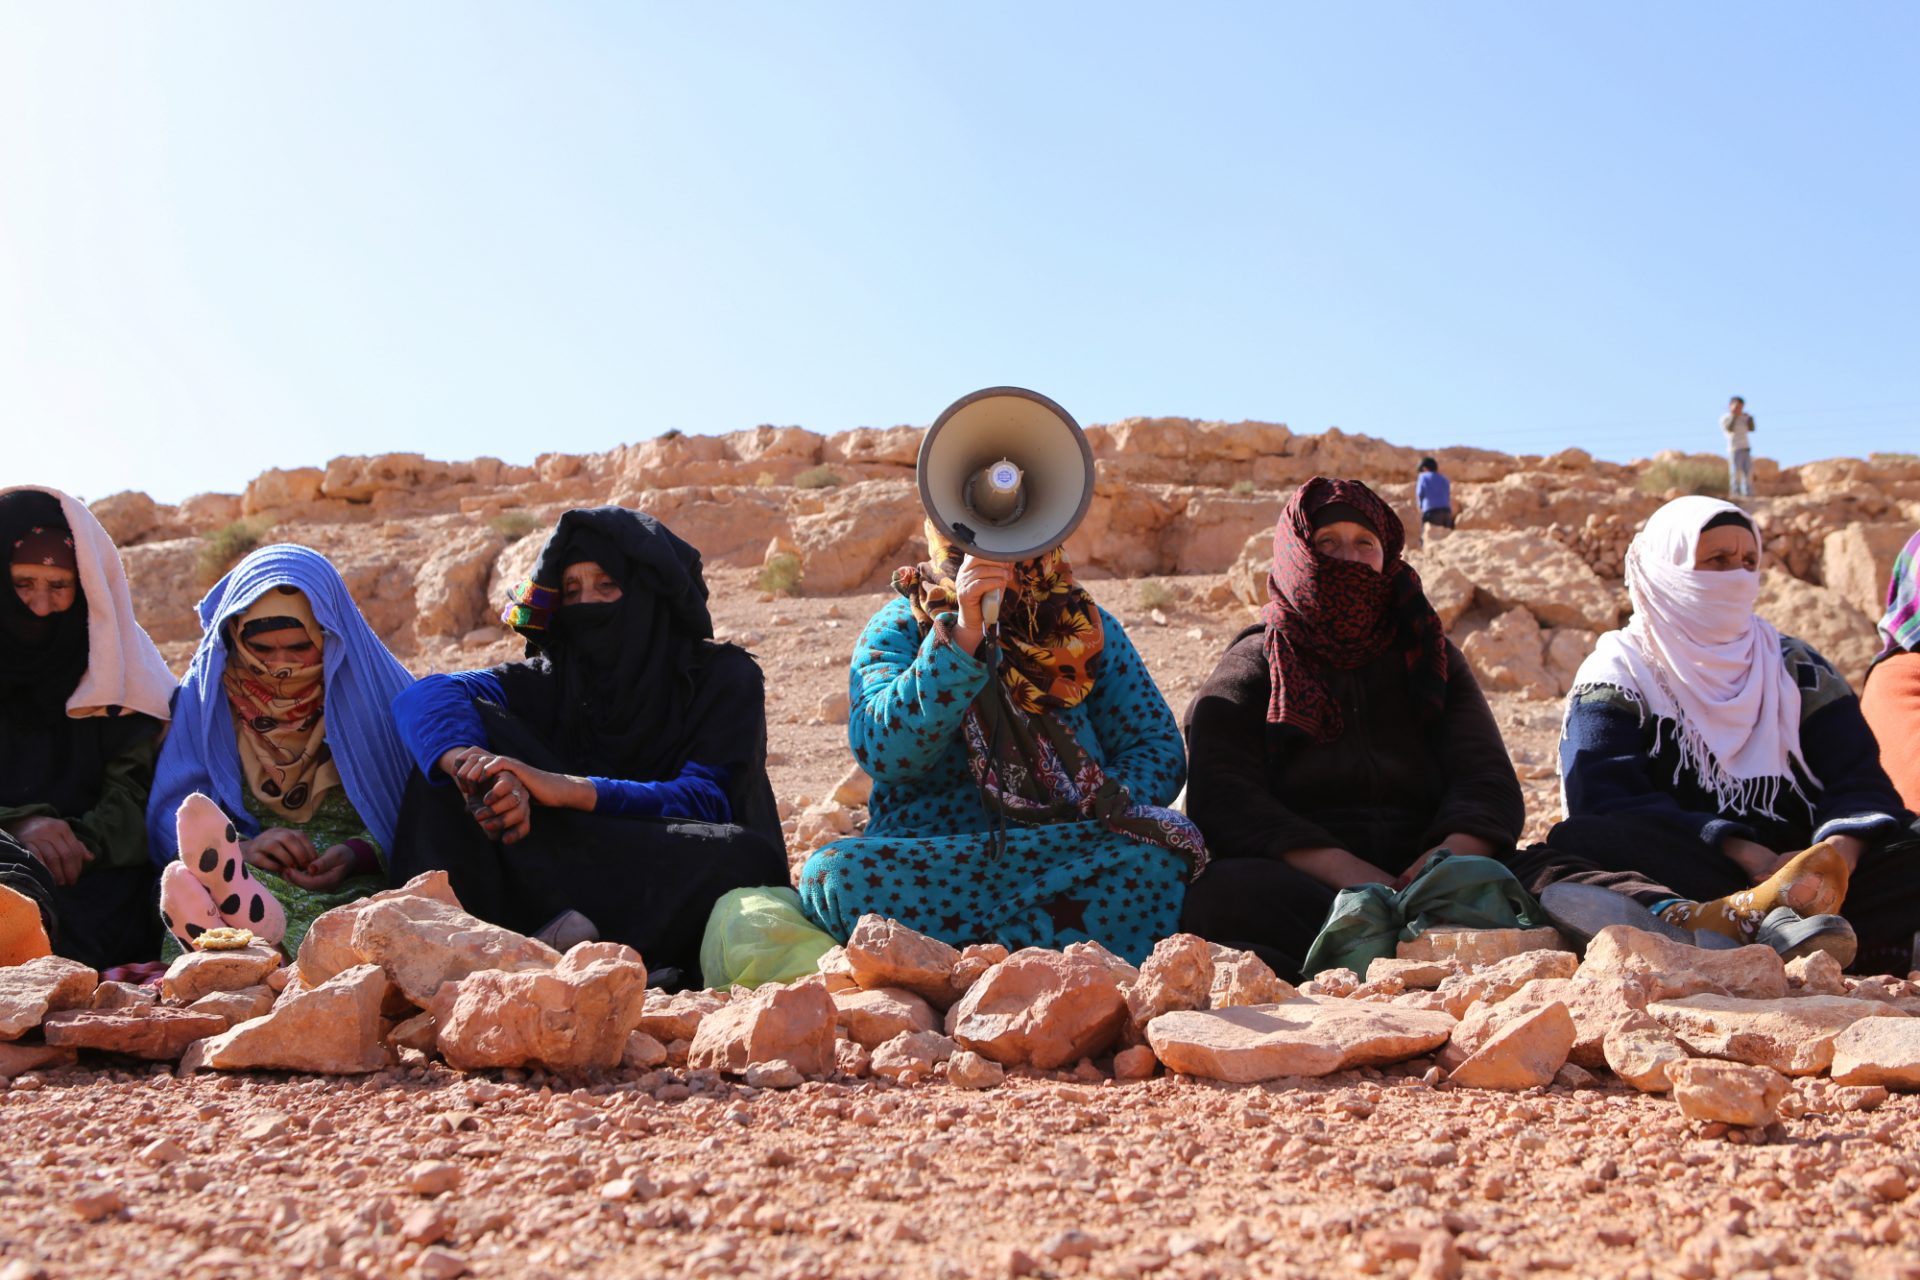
(146, 543), (413, 954)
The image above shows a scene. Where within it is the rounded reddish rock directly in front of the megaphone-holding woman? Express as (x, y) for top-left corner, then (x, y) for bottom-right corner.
(948, 946), (1127, 1071)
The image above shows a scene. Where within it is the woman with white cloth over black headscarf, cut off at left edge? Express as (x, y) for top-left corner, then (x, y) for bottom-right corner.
(0, 487), (175, 969)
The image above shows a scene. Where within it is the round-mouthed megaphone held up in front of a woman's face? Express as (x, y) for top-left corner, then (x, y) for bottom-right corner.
(916, 386), (1092, 626)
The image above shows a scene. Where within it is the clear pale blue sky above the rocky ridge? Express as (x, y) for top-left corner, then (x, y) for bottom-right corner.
(0, 0), (1920, 499)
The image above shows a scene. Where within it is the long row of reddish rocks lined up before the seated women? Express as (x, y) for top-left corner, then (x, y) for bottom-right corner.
(0, 886), (1920, 1126)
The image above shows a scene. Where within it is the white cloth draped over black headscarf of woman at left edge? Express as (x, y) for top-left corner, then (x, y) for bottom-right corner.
(0, 484), (180, 720)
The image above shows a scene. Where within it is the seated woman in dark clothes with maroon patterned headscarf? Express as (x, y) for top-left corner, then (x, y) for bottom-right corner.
(1181, 476), (1524, 977)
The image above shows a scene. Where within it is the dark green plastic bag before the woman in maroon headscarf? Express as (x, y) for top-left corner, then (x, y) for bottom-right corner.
(1302, 848), (1546, 977)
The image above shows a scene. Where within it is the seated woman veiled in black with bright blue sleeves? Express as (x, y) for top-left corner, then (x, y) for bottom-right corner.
(394, 507), (787, 984)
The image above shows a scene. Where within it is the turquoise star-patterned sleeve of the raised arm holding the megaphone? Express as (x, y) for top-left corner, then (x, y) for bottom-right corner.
(847, 601), (987, 781)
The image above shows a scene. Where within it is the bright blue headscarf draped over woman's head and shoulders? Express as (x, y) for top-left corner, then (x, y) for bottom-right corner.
(146, 543), (413, 865)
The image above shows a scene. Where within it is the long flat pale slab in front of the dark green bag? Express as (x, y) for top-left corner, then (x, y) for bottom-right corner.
(1146, 996), (1453, 1084)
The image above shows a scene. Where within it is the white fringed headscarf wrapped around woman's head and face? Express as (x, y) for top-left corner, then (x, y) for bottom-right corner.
(1569, 497), (1818, 818)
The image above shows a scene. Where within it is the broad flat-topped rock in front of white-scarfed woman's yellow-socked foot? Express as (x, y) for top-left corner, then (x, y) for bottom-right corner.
(1647, 997), (1905, 1075)
